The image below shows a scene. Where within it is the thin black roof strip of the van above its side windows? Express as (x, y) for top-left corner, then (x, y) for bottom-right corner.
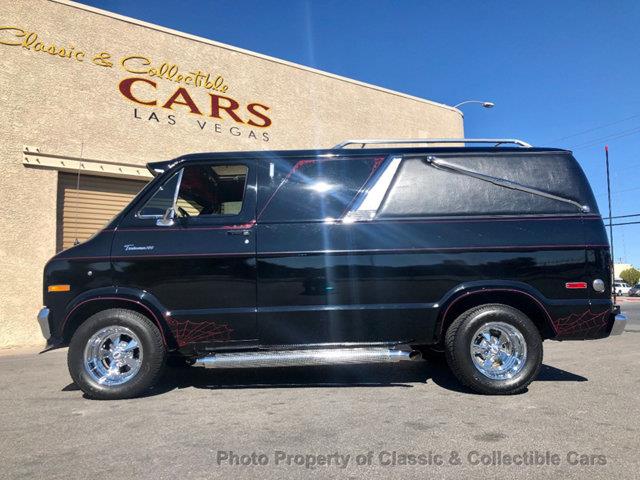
(147, 146), (572, 176)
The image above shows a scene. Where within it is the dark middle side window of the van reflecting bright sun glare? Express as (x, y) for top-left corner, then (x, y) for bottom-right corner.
(259, 156), (385, 222)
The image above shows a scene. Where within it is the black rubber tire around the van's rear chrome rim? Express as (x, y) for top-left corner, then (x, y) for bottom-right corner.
(445, 304), (542, 395)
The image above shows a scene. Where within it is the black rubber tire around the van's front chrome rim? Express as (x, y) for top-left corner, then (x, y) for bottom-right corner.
(67, 308), (167, 400)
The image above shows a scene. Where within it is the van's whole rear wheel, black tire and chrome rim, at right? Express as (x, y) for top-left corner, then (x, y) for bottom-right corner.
(445, 304), (542, 395)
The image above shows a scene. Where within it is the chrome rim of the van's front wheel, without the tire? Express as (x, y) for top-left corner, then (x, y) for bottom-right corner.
(84, 325), (142, 386)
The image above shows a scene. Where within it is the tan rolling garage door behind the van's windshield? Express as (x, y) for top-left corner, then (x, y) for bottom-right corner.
(57, 173), (148, 251)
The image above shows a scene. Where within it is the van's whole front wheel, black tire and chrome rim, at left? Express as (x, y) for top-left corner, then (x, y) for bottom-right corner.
(67, 308), (166, 400)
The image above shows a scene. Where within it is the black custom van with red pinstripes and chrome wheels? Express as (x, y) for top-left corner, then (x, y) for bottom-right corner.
(39, 139), (626, 399)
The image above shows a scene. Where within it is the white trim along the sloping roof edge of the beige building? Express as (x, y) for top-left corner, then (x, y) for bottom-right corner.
(49, 0), (463, 116)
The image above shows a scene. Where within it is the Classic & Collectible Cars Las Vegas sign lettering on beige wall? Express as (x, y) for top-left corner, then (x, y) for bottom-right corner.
(0, 26), (273, 142)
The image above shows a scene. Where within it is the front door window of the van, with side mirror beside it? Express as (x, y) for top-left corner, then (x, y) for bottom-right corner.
(138, 165), (248, 218)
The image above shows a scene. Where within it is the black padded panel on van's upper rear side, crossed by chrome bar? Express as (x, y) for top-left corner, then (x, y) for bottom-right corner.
(377, 154), (595, 218)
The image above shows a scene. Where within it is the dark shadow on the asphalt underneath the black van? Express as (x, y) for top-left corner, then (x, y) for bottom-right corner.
(63, 361), (587, 396)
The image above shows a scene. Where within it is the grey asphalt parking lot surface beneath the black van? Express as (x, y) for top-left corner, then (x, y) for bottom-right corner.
(0, 318), (640, 479)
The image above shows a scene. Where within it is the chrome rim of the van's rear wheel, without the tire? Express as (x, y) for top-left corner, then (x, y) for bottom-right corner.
(470, 322), (527, 380)
